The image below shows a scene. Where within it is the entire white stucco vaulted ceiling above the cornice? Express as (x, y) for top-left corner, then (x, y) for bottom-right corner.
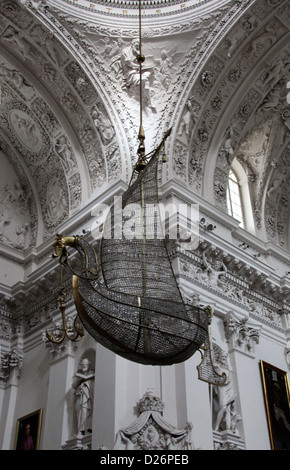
(0, 0), (290, 262)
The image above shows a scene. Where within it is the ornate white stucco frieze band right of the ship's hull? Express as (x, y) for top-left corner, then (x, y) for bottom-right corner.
(180, 243), (285, 328)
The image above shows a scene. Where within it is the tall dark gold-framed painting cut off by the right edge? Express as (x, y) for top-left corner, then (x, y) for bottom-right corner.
(260, 361), (290, 450)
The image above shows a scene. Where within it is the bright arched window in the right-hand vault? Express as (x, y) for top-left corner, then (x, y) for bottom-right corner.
(227, 159), (255, 233)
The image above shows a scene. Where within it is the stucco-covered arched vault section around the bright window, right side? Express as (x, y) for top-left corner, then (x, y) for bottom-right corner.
(170, 0), (290, 249)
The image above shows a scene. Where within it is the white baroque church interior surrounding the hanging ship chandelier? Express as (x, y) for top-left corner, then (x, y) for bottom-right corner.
(0, 0), (290, 450)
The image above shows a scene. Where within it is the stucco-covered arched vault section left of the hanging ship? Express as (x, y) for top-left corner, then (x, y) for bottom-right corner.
(0, 1), (128, 248)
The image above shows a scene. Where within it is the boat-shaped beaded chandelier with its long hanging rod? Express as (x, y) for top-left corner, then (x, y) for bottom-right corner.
(48, 0), (224, 384)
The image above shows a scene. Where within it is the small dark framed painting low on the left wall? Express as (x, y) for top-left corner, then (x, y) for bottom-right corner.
(15, 409), (42, 450)
